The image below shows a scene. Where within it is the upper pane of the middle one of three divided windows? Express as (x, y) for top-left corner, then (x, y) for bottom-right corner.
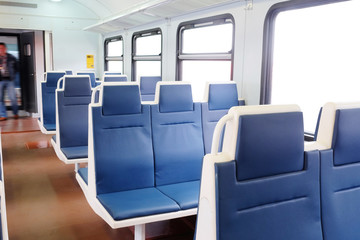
(136, 34), (161, 55)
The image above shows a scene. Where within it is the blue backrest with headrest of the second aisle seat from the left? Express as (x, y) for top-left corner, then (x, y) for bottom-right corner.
(57, 76), (91, 147)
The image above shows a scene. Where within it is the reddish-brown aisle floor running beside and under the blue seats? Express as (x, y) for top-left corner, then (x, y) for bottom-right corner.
(0, 117), (196, 240)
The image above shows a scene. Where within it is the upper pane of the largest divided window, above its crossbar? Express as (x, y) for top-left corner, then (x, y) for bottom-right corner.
(182, 24), (233, 53)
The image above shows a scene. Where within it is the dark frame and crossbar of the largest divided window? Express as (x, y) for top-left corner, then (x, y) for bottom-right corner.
(176, 13), (235, 81)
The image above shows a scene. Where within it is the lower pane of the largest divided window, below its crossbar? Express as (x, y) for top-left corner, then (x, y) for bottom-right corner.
(182, 61), (231, 101)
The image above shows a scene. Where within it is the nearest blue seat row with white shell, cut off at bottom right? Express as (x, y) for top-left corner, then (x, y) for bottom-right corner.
(195, 103), (360, 240)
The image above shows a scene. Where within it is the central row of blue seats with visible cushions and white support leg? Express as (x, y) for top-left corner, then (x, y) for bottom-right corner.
(76, 82), (245, 239)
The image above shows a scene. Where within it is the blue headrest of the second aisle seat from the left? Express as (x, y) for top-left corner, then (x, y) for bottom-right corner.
(64, 76), (91, 97)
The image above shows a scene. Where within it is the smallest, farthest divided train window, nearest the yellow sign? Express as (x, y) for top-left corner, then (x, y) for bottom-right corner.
(105, 36), (124, 73)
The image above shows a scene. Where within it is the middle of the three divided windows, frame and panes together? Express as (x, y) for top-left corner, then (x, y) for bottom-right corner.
(132, 29), (162, 81)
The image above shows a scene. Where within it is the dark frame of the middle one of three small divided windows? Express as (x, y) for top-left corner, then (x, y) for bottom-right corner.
(131, 28), (163, 82)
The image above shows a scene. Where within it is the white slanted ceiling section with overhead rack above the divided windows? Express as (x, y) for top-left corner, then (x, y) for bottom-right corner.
(75, 0), (240, 33)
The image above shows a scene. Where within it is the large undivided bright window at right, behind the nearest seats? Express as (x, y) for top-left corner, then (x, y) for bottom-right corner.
(262, 1), (360, 133)
